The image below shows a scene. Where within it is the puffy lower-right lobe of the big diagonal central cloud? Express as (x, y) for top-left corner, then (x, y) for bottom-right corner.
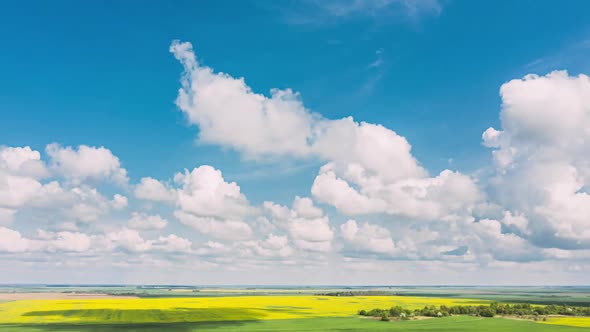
(311, 164), (483, 220)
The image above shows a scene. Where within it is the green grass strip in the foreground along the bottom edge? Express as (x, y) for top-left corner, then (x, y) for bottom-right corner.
(0, 316), (590, 332)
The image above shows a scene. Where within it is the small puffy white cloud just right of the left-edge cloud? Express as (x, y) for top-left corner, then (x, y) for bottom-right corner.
(45, 143), (128, 184)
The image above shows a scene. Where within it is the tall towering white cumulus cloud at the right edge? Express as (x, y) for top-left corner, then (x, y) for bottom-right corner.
(483, 71), (590, 248)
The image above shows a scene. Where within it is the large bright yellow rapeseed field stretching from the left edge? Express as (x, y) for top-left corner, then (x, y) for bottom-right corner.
(0, 295), (486, 324)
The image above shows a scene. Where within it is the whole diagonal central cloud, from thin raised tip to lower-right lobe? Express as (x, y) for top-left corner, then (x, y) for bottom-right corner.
(170, 42), (480, 223)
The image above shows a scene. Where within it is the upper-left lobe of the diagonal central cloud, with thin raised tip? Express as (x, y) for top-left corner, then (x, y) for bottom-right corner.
(170, 42), (320, 156)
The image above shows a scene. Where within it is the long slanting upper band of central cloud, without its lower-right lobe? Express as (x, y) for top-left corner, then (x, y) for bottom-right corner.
(170, 42), (425, 179)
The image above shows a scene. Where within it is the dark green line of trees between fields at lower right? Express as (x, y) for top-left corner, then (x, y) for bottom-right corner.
(358, 302), (590, 321)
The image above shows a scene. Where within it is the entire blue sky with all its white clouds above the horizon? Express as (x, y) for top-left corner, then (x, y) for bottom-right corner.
(0, 0), (590, 285)
